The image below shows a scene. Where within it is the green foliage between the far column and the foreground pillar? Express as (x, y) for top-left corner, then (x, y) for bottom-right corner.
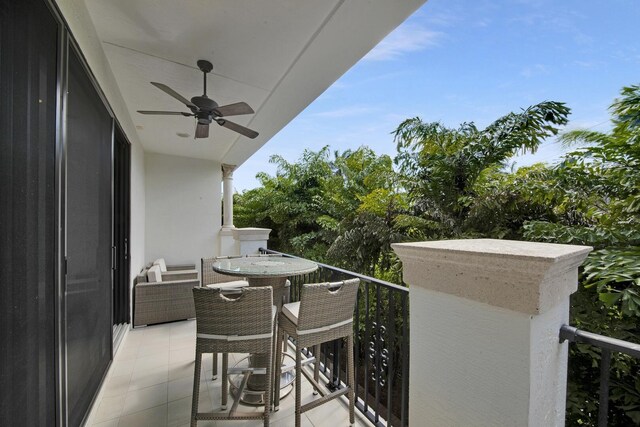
(235, 147), (407, 268)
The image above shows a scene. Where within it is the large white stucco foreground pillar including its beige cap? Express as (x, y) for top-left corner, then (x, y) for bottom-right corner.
(393, 239), (591, 427)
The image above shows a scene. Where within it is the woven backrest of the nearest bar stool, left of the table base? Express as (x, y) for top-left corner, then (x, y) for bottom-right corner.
(193, 286), (273, 336)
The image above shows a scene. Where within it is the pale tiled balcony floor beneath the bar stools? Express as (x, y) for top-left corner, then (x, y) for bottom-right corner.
(89, 320), (370, 427)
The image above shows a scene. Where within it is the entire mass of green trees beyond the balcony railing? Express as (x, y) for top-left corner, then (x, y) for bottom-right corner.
(235, 85), (640, 425)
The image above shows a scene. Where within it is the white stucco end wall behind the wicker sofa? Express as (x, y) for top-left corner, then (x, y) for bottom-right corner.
(145, 153), (222, 266)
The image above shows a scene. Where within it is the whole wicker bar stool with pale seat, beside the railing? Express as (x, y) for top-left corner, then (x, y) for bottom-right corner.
(274, 279), (360, 427)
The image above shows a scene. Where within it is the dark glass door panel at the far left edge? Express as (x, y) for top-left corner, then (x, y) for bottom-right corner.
(0, 0), (58, 426)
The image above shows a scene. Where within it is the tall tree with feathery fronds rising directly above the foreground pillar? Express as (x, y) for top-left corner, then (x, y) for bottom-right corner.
(394, 102), (569, 238)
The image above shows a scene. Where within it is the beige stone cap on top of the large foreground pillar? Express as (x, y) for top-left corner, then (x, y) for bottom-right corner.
(392, 239), (593, 314)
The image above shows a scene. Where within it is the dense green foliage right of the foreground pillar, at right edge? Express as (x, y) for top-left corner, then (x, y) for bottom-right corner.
(524, 86), (640, 425)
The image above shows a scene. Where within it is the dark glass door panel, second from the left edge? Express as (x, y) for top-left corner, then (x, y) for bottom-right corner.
(66, 49), (112, 426)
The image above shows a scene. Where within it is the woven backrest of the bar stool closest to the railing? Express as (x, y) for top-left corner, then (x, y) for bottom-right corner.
(298, 279), (360, 330)
